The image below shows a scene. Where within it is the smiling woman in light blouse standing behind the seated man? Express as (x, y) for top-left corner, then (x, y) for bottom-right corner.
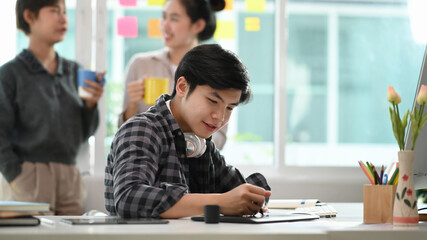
(119, 0), (227, 149)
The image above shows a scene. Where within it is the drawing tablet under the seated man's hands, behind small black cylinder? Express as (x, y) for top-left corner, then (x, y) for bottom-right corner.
(191, 213), (319, 223)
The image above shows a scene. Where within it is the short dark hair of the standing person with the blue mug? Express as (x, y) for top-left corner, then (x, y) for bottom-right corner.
(15, 0), (60, 35)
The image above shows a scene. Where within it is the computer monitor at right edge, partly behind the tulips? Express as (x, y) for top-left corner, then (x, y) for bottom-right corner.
(405, 44), (427, 189)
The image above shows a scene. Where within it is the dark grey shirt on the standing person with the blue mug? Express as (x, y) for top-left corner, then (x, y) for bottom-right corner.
(0, 50), (98, 182)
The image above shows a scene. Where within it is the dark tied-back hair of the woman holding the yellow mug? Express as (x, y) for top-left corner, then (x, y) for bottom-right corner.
(180, 0), (225, 41)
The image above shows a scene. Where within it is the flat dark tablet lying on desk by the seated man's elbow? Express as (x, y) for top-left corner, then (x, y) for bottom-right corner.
(61, 217), (169, 225)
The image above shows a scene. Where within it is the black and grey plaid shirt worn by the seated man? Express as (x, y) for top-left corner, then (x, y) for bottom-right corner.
(104, 95), (270, 217)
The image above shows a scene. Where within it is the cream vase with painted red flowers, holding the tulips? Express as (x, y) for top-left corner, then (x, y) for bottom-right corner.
(393, 151), (418, 225)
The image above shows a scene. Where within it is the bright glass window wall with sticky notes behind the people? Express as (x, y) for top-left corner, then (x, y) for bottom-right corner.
(0, 0), (427, 184)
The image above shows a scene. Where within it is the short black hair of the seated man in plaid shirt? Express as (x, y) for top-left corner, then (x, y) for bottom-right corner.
(172, 44), (251, 103)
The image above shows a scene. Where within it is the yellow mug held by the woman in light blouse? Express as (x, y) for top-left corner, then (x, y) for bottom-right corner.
(144, 78), (169, 105)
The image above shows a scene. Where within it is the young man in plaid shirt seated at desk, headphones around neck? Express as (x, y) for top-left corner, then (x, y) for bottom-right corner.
(105, 45), (271, 218)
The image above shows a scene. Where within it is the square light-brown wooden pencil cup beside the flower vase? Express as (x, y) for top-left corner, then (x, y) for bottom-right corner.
(363, 184), (396, 223)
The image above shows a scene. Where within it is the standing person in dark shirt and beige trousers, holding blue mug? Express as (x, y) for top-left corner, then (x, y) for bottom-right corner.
(0, 0), (103, 215)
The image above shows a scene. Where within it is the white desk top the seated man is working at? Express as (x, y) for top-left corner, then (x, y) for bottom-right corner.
(0, 203), (427, 240)
